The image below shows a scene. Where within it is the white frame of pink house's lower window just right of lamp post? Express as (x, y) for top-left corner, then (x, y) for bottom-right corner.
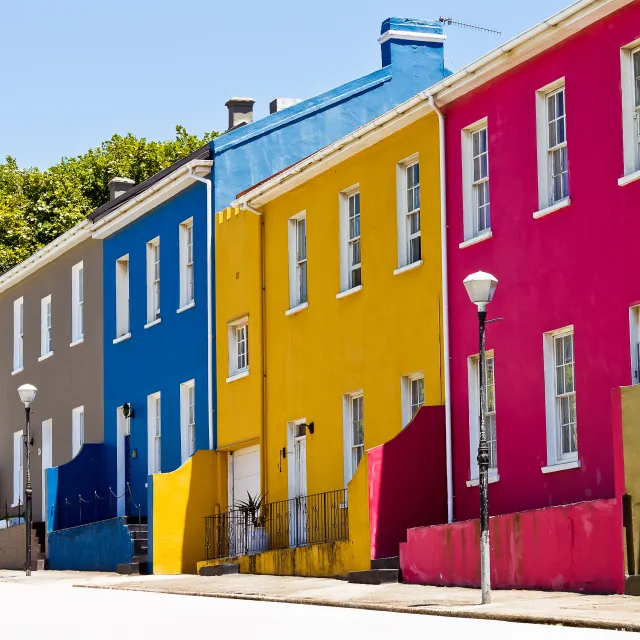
(543, 325), (580, 473)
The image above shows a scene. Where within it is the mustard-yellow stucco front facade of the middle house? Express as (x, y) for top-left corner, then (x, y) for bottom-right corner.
(216, 115), (444, 501)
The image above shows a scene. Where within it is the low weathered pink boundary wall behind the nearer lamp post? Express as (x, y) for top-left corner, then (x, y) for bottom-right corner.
(400, 499), (625, 593)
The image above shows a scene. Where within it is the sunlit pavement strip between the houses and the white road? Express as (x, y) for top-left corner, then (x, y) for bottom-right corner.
(0, 571), (640, 633)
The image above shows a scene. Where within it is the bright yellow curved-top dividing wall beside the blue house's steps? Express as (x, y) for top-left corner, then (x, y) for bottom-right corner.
(153, 450), (227, 574)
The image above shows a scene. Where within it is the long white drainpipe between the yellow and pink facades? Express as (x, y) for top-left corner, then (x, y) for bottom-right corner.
(429, 94), (453, 523)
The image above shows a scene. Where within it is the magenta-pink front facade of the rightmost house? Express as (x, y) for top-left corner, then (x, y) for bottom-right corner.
(445, 2), (640, 520)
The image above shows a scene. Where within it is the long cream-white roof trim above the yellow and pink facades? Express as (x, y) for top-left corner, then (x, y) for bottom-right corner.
(231, 0), (635, 207)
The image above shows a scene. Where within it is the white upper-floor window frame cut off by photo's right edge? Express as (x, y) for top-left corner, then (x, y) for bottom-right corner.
(619, 39), (640, 184)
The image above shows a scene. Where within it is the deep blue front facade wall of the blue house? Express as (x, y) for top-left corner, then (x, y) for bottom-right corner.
(103, 182), (209, 515)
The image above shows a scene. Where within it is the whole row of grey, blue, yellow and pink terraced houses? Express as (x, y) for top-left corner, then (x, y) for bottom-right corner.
(0, 0), (640, 593)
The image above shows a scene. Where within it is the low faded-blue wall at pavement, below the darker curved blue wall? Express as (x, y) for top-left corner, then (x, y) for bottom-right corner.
(48, 518), (133, 571)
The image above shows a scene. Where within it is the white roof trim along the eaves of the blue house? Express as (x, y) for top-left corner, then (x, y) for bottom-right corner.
(92, 160), (213, 240)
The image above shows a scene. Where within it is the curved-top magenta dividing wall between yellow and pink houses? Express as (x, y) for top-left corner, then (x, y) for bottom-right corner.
(368, 407), (447, 558)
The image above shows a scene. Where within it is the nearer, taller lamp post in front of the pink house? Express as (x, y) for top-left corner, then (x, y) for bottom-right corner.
(464, 271), (498, 604)
